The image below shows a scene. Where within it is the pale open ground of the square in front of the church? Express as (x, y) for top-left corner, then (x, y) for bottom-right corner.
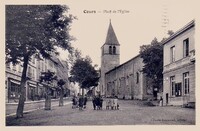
(6, 100), (195, 126)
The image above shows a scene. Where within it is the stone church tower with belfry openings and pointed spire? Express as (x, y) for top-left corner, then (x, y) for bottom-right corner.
(100, 20), (120, 95)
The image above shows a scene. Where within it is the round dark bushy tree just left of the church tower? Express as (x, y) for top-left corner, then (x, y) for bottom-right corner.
(69, 56), (99, 96)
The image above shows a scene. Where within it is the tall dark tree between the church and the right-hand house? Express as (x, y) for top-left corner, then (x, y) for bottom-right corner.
(140, 38), (163, 97)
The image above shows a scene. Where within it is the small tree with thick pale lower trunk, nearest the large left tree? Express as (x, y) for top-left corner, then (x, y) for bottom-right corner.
(40, 70), (57, 110)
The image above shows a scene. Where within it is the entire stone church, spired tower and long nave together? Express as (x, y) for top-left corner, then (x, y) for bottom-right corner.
(100, 21), (152, 100)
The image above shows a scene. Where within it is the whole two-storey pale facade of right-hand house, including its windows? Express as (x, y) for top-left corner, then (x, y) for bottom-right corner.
(163, 20), (195, 105)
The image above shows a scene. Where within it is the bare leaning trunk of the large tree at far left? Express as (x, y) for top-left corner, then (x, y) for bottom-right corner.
(16, 56), (28, 118)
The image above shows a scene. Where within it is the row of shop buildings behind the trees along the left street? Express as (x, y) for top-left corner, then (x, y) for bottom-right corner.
(5, 53), (69, 102)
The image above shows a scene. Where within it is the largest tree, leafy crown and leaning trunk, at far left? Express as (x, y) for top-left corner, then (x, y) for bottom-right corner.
(6, 5), (75, 118)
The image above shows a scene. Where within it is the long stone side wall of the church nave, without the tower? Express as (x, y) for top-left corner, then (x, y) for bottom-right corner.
(105, 55), (152, 100)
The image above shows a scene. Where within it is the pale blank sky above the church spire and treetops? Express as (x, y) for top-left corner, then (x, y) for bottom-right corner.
(56, 0), (195, 67)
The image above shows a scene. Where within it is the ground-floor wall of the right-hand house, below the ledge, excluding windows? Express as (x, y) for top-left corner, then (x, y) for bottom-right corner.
(163, 63), (195, 105)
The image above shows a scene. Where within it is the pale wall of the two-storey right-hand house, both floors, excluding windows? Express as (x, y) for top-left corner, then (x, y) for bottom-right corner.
(163, 24), (195, 105)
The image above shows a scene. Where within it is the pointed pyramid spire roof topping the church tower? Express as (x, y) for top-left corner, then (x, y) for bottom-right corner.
(105, 21), (119, 45)
